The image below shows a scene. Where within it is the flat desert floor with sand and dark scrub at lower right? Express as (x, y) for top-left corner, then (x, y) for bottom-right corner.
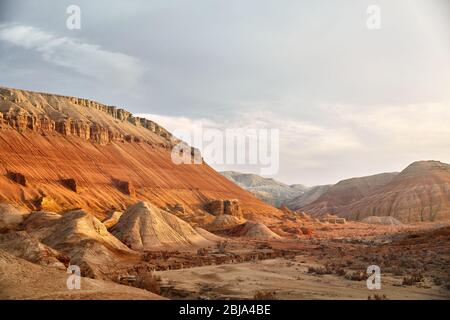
(156, 222), (450, 299)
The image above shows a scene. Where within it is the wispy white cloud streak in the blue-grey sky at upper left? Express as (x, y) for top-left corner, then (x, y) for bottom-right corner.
(0, 25), (143, 90)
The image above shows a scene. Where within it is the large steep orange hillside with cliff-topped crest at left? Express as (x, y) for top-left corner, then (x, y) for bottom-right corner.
(0, 89), (281, 222)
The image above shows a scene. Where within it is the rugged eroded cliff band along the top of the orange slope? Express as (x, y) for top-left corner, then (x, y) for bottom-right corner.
(0, 88), (179, 146)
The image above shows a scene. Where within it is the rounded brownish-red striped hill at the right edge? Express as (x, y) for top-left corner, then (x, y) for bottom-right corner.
(302, 161), (450, 222)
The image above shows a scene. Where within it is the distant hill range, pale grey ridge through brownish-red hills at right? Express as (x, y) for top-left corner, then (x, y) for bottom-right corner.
(222, 161), (450, 222)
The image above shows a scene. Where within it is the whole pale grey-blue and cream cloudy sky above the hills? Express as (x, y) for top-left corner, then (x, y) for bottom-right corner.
(0, 0), (450, 186)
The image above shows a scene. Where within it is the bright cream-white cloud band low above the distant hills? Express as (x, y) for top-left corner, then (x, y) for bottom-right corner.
(140, 103), (450, 185)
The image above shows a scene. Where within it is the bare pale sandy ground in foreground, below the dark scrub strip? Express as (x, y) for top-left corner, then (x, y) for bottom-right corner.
(157, 257), (450, 299)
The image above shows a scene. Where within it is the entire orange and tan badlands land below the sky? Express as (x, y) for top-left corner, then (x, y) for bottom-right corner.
(0, 88), (450, 299)
